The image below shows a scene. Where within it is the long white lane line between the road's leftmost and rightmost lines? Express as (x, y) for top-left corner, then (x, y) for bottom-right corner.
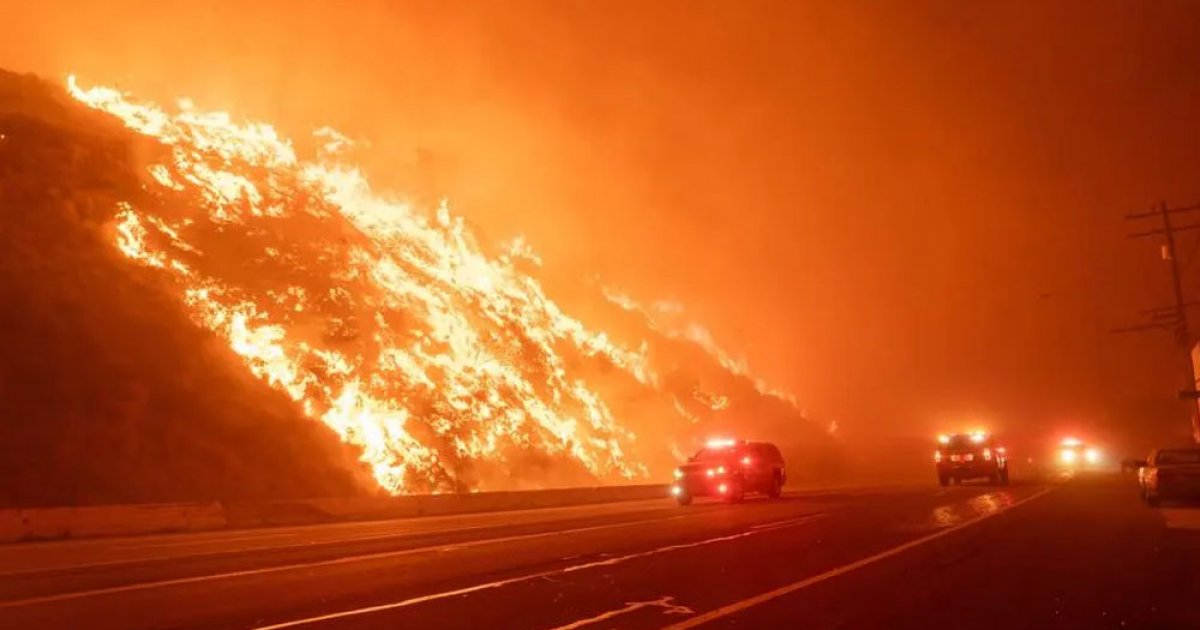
(243, 512), (826, 630)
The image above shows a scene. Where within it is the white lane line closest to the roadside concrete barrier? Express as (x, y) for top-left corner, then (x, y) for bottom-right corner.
(0, 512), (703, 608)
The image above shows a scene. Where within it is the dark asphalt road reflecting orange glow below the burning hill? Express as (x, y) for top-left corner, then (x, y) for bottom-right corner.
(0, 476), (1200, 629)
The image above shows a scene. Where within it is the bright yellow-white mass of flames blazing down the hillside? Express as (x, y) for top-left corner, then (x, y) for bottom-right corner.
(67, 77), (796, 493)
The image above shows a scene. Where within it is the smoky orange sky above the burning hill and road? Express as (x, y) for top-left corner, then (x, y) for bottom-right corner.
(9, 0), (1200, 445)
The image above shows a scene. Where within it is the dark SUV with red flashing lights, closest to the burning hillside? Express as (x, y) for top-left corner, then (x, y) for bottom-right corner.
(671, 439), (787, 505)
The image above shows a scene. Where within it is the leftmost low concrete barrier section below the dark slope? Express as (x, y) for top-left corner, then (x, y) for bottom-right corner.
(0, 502), (228, 542)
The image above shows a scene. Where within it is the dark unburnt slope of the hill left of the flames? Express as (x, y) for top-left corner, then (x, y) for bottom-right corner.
(0, 71), (373, 506)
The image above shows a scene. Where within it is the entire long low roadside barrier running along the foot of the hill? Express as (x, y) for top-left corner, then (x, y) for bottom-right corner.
(0, 485), (667, 542)
